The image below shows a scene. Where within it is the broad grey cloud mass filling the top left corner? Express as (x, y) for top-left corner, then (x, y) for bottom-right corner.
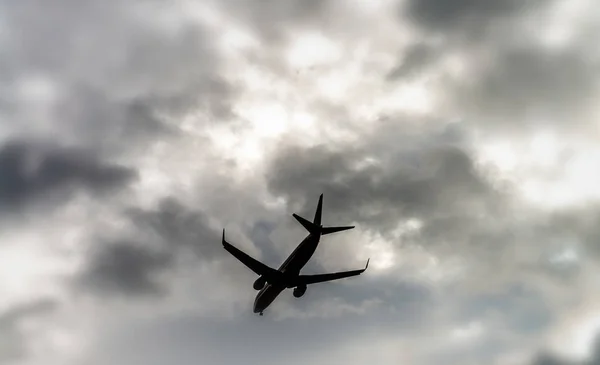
(0, 0), (233, 154)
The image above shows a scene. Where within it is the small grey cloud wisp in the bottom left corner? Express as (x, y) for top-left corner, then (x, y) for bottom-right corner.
(0, 299), (57, 363)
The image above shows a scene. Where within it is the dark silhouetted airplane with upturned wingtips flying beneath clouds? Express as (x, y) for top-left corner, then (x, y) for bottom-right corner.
(222, 194), (370, 316)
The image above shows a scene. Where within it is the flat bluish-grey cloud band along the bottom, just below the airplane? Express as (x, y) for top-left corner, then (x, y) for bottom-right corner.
(88, 276), (435, 365)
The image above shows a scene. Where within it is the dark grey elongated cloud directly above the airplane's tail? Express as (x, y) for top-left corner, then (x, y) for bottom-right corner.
(268, 132), (495, 227)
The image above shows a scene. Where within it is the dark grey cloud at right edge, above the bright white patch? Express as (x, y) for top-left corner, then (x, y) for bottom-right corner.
(458, 44), (600, 126)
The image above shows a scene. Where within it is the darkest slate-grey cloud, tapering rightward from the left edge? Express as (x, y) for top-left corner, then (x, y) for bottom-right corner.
(0, 141), (135, 210)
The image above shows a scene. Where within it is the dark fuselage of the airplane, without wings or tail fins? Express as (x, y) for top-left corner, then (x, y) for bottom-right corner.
(254, 234), (321, 313)
